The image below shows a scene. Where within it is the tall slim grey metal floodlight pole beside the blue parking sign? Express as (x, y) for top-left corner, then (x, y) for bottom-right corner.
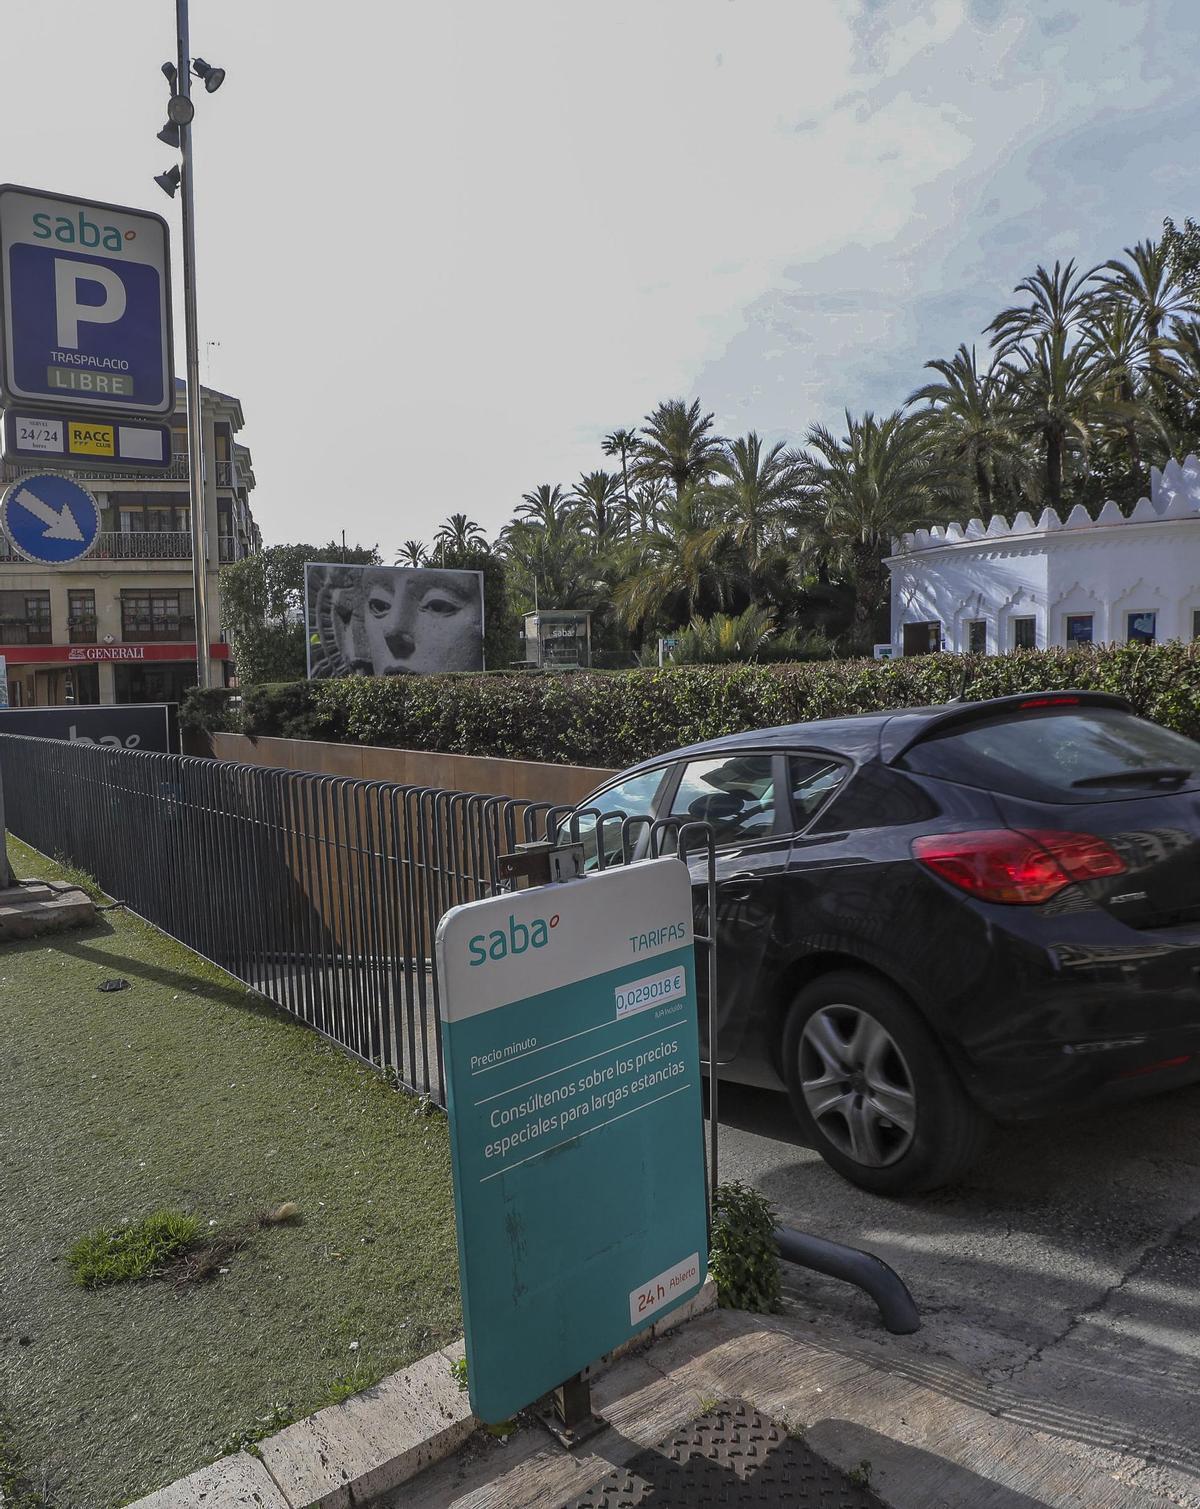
(175, 0), (211, 691)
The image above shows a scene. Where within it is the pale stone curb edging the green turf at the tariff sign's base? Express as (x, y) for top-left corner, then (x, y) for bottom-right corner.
(126, 1280), (717, 1509)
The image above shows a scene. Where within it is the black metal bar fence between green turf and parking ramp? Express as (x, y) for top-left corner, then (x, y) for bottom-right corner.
(0, 735), (715, 1103)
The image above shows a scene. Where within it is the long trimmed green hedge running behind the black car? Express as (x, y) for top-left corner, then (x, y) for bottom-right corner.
(180, 643), (1200, 767)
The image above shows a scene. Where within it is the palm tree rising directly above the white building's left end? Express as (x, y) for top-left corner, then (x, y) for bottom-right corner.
(904, 346), (1019, 513)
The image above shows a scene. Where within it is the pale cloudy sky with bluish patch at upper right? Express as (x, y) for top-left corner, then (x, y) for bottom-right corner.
(0, 0), (1200, 560)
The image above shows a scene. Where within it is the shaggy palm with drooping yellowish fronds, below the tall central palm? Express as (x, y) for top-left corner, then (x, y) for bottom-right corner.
(613, 486), (744, 632)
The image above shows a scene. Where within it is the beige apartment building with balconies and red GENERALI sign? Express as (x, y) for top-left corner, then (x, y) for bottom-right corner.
(0, 382), (261, 706)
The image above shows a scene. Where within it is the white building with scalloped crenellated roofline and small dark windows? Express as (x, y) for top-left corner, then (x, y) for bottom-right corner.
(888, 456), (1200, 655)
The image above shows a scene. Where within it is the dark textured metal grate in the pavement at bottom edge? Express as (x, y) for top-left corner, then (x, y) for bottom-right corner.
(563, 1403), (882, 1509)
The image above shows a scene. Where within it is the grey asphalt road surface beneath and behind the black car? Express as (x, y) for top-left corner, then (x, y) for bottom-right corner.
(720, 1085), (1200, 1509)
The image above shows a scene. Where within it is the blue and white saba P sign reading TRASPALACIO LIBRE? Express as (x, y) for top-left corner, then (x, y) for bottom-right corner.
(0, 184), (175, 415)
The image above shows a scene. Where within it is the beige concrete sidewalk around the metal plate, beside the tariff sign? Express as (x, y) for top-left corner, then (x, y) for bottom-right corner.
(392, 1311), (1173, 1509)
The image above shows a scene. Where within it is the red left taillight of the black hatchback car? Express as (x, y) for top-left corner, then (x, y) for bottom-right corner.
(913, 828), (1125, 907)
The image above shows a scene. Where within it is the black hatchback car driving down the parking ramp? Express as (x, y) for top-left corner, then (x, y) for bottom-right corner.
(575, 691), (1200, 1194)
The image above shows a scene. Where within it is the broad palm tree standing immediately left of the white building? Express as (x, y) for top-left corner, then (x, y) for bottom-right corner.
(803, 410), (943, 650)
